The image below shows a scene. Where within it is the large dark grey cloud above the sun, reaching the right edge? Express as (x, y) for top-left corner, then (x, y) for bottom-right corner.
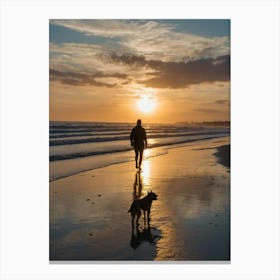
(111, 54), (230, 88)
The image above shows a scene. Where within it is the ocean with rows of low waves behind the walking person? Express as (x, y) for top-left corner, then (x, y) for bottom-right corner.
(49, 122), (230, 181)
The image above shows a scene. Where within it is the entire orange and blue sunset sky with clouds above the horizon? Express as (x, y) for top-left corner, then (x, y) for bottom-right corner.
(50, 20), (230, 123)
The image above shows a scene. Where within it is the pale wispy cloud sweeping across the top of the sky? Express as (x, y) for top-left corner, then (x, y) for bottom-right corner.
(50, 20), (230, 61)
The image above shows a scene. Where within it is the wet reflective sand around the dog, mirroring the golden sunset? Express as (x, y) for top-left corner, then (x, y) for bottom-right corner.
(50, 137), (230, 261)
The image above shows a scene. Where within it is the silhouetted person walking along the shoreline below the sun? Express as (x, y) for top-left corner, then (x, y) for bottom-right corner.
(130, 119), (147, 169)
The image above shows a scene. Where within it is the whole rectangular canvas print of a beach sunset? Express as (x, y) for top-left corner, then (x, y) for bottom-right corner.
(49, 19), (231, 262)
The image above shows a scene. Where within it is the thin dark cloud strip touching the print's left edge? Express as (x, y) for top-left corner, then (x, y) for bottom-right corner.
(50, 69), (127, 87)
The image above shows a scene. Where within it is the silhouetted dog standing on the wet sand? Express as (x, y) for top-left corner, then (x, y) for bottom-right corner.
(128, 191), (158, 226)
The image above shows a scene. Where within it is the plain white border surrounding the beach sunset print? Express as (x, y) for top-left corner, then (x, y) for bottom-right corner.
(0, 0), (280, 280)
